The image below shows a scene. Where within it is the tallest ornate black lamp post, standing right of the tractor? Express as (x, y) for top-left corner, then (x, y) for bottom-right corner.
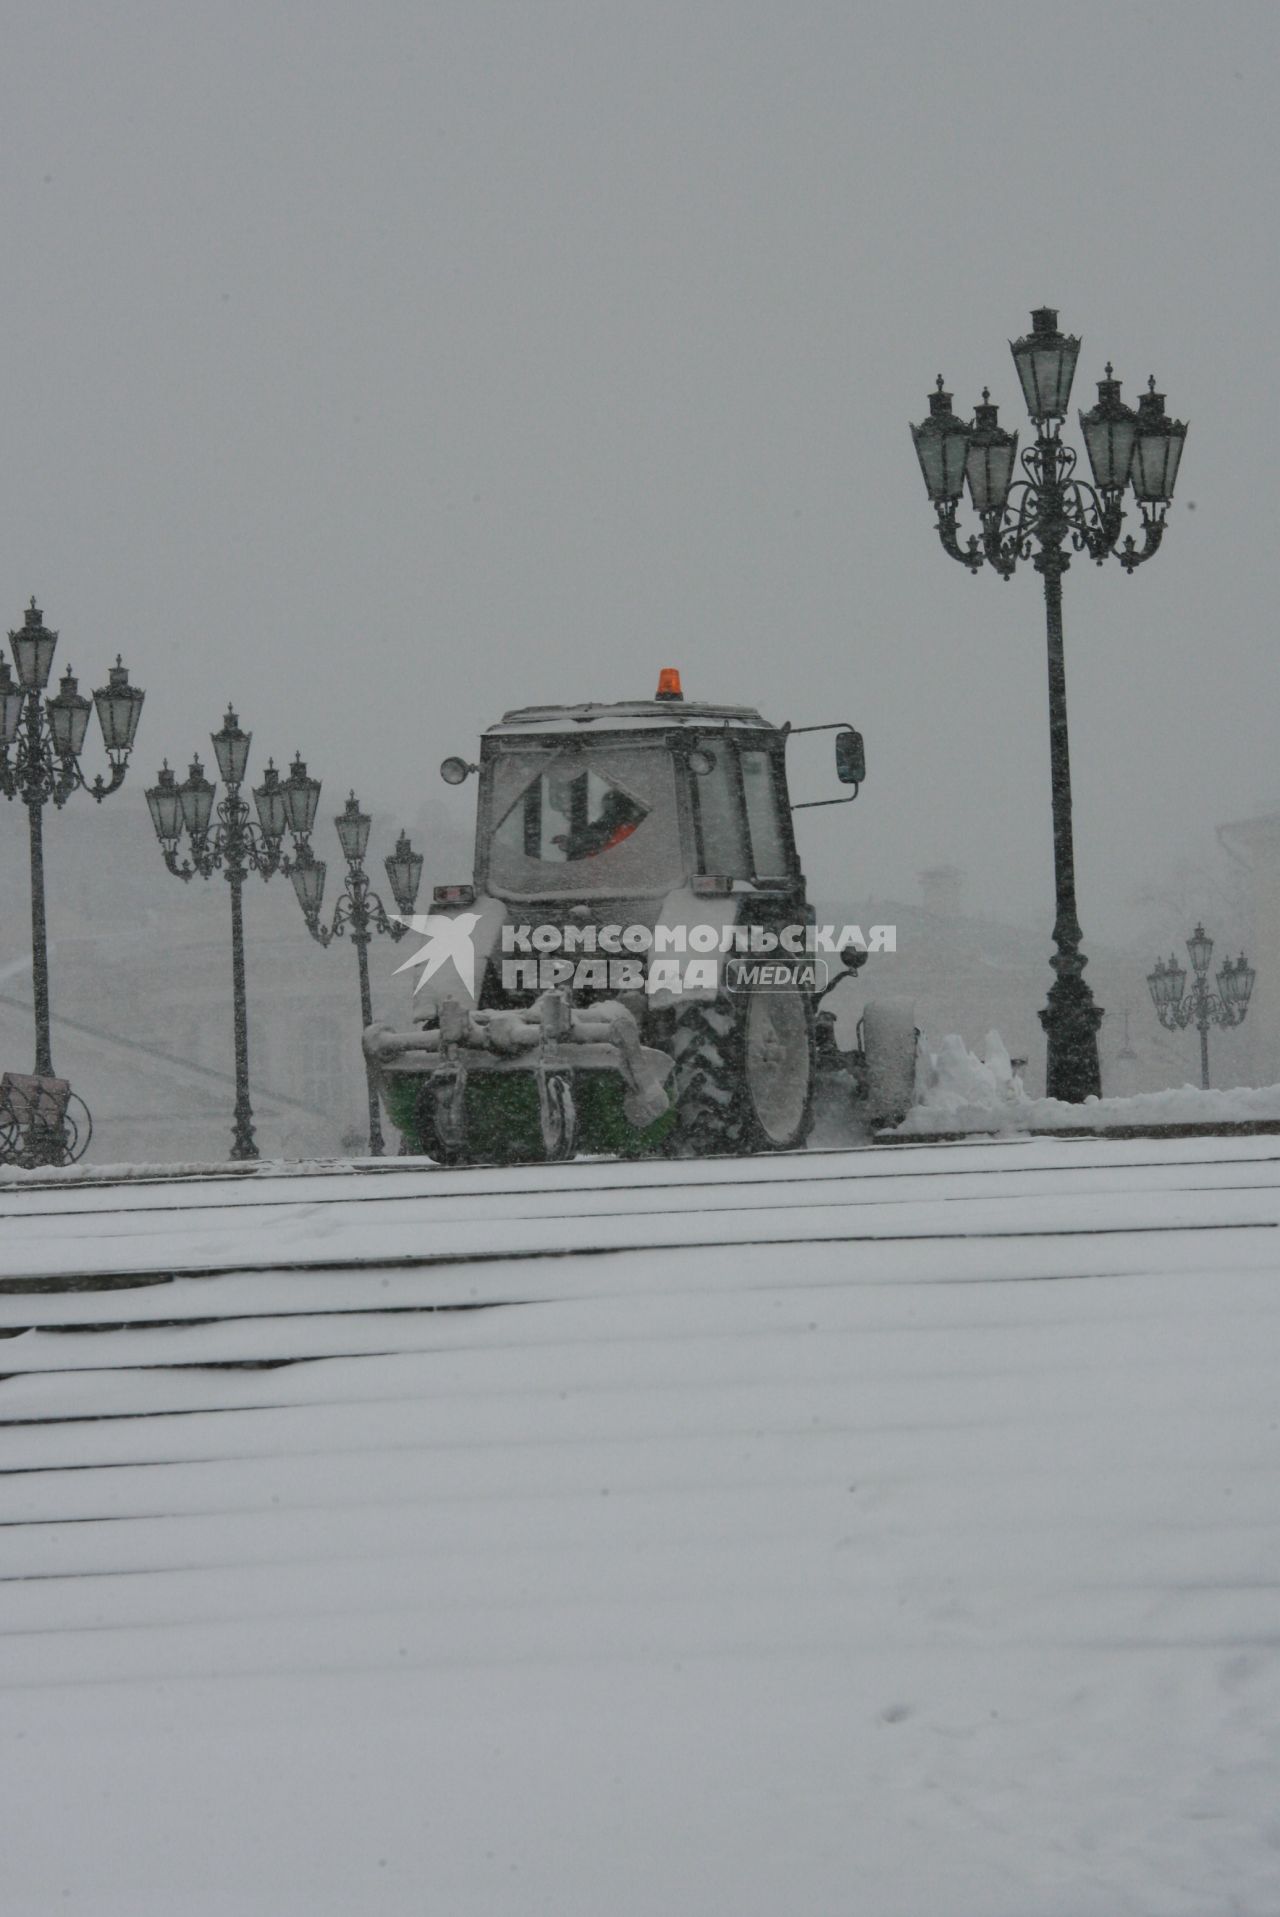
(912, 307), (1186, 1104)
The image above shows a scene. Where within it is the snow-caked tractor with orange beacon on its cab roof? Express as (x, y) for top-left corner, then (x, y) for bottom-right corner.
(364, 667), (916, 1164)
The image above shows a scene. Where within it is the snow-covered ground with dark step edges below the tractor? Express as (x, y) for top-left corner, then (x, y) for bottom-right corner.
(0, 1139), (1280, 1917)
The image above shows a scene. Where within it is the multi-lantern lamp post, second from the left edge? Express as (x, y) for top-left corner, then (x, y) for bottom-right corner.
(148, 705), (320, 1158)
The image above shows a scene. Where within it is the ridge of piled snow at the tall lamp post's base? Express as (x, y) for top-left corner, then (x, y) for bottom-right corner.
(895, 1031), (1280, 1137)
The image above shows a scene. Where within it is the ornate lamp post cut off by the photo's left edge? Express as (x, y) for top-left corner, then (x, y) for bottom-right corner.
(0, 598), (146, 1104)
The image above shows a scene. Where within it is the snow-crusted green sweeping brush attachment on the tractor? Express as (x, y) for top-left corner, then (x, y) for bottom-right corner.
(364, 991), (673, 1164)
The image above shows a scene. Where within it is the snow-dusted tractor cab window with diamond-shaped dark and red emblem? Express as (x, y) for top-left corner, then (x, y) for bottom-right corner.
(489, 744), (682, 897)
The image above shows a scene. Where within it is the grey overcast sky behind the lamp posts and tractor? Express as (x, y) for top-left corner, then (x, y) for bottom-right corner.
(0, 0), (1280, 937)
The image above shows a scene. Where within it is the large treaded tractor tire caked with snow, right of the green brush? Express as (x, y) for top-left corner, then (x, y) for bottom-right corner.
(667, 993), (816, 1158)
